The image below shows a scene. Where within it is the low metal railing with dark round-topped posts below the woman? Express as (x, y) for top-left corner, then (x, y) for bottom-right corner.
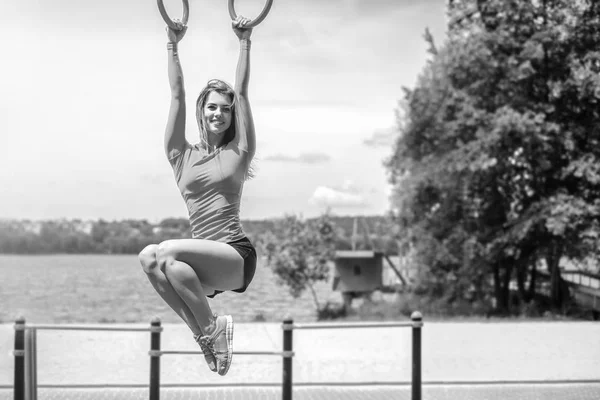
(13, 311), (423, 400)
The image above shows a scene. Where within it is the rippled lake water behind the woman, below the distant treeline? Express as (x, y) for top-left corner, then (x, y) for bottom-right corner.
(0, 255), (340, 323)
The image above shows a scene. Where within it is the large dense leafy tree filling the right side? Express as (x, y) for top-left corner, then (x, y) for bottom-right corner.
(387, 0), (600, 311)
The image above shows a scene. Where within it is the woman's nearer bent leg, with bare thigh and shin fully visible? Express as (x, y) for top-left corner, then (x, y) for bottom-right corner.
(157, 239), (244, 333)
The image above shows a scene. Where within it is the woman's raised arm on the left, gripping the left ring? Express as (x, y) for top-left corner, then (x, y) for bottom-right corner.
(165, 21), (187, 159)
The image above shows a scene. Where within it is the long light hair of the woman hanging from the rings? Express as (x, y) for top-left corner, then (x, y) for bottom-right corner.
(196, 79), (256, 179)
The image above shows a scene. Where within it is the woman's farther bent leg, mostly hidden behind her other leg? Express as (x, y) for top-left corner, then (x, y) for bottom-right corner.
(138, 244), (202, 335)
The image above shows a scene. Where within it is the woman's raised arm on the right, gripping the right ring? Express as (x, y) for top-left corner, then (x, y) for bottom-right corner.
(232, 16), (256, 158)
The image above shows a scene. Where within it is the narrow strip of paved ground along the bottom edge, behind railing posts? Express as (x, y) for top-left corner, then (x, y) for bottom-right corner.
(0, 384), (600, 400)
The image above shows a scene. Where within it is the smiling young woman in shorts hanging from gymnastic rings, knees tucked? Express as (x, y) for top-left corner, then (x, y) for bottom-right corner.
(139, 16), (256, 375)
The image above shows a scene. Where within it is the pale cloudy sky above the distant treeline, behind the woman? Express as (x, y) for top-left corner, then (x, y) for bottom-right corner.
(0, 0), (446, 221)
